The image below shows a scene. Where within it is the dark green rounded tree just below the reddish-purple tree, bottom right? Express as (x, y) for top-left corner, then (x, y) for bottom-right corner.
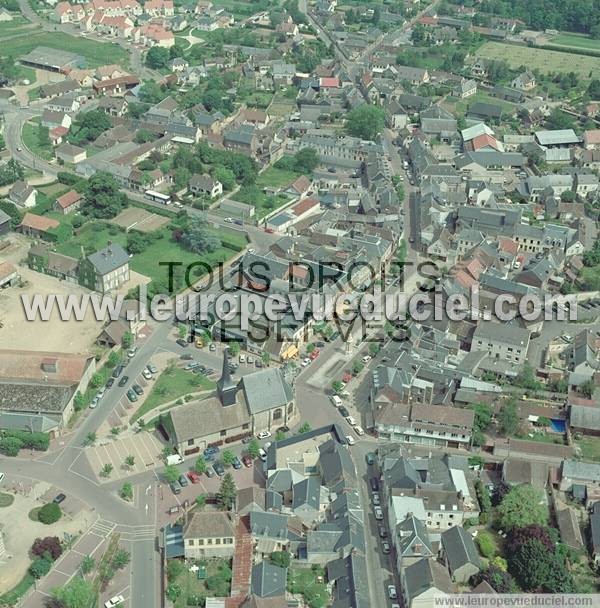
(508, 538), (574, 593)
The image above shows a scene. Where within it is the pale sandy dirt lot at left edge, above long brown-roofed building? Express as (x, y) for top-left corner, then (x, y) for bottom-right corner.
(0, 233), (102, 353)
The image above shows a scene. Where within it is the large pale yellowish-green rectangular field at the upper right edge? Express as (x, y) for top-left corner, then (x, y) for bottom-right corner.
(477, 42), (600, 79)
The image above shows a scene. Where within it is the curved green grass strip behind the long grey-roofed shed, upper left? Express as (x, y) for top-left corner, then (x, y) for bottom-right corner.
(2, 32), (129, 67)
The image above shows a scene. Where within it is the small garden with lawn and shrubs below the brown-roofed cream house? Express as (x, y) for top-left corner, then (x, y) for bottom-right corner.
(174, 558), (231, 608)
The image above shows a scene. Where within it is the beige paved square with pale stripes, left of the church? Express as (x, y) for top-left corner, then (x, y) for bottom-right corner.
(85, 431), (163, 482)
